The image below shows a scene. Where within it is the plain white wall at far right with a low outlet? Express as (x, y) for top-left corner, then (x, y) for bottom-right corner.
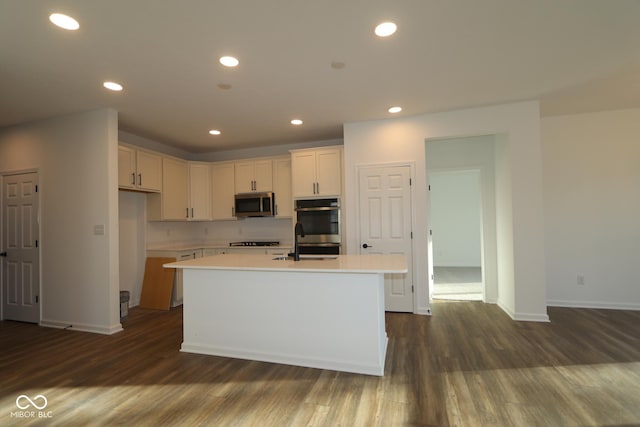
(542, 109), (640, 310)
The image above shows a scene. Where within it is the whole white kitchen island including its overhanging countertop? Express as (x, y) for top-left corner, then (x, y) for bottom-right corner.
(165, 254), (407, 376)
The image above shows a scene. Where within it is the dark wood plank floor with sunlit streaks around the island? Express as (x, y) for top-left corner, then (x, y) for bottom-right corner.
(0, 302), (640, 426)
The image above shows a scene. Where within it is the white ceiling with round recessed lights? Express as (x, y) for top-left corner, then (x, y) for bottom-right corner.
(0, 0), (640, 153)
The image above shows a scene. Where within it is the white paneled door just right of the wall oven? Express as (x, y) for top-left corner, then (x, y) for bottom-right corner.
(359, 166), (414, 312)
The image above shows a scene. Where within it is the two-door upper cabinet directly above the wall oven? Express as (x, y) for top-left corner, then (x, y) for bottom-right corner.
(291, 147), (342, 198)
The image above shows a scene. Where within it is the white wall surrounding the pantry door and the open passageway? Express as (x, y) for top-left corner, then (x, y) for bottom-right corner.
(344, 102), (548, 321)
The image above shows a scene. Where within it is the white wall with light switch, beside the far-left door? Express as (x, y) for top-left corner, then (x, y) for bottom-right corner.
(0, 109), (121, 334)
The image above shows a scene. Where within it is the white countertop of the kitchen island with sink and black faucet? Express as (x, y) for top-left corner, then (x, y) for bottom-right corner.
(164, 254), (408, 274)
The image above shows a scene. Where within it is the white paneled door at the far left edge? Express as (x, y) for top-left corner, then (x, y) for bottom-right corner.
(2, 173), (40, 323)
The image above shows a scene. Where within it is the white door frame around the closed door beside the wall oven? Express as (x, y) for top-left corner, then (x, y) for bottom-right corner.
(355, 161), (420, 314)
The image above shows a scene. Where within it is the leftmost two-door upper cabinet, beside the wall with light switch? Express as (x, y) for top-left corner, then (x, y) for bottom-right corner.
(118, 145), (162, 192)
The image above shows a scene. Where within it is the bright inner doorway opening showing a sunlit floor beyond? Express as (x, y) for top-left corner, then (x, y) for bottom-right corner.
(429, 169), (485, 301)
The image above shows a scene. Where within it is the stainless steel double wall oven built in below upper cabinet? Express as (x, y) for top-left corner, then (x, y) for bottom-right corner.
(295, 198), (342, 255)
